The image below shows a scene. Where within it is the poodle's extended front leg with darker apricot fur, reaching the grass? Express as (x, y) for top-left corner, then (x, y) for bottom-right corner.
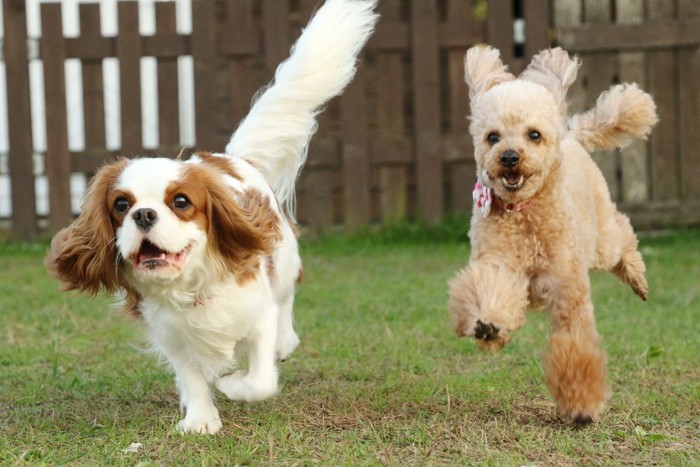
(544, 272), (609, 424)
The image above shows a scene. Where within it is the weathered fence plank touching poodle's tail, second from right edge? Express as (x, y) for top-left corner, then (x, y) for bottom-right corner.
(647, 0), (681, 201)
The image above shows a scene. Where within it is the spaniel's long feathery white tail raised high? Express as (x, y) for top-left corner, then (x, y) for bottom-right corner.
(226, 0), (378, 218)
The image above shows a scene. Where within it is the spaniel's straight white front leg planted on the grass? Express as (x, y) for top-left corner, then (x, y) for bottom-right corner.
(170, 359), (221, 435)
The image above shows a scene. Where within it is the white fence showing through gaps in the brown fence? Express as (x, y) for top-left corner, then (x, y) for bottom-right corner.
(0, 0), (195, 219)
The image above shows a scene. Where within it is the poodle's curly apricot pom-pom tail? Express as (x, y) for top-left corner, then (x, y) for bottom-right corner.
(569, 84), (659, 151)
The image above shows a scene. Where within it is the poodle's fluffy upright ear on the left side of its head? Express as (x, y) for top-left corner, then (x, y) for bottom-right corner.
(464, 45), (515, 101)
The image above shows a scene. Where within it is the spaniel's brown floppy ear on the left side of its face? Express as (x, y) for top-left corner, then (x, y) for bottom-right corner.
(44, 159), (128, 295)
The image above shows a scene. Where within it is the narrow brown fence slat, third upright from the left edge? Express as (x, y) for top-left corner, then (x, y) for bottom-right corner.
(79, 3), (106, 147)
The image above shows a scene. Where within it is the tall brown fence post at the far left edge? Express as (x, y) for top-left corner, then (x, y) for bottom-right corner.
(2, 0), (37, 240)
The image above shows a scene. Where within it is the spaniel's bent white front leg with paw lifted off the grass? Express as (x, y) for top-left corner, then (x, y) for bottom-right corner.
(216, 305), (279, 402)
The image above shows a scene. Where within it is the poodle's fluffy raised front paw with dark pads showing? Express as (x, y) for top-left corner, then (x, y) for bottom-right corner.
(449, 261), (528, 351)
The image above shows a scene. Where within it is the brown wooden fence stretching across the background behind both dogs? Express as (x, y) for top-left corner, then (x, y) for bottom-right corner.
(3, 0), (700, 237)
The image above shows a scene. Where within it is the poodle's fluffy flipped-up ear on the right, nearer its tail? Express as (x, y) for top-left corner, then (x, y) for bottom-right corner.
(518, 47), (581, 117)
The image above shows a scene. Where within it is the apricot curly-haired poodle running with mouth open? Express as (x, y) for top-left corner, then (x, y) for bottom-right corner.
(449, 47), (657, 423)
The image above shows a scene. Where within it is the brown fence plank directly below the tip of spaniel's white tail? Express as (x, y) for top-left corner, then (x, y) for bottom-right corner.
(340, 66), (371, 230)
